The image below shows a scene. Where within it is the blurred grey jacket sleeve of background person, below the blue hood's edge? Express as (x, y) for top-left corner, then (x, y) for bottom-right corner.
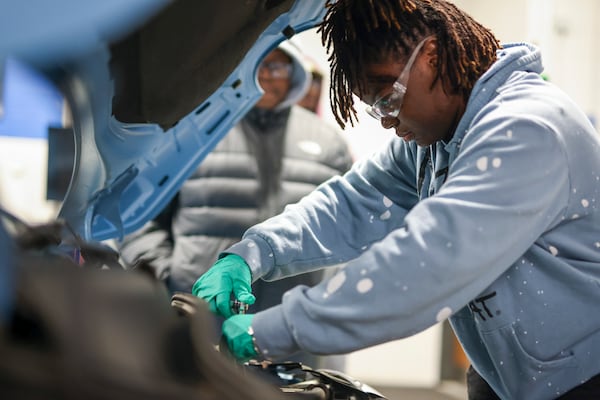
(119, 195), (179, 281)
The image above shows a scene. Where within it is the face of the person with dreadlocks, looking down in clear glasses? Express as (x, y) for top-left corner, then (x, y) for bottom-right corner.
(356, 37), (464, 146)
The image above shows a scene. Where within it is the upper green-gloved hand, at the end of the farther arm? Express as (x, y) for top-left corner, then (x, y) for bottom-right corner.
(192, 254), (256, 318)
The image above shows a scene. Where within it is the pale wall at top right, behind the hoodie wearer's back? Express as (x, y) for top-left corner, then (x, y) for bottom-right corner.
(454, 0), (600, 125)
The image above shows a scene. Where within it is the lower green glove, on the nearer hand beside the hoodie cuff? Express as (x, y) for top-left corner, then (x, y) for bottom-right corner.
(222, 314), (258, 362)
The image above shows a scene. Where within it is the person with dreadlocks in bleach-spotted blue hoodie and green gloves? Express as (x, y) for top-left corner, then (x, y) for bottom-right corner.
(193, 0), (600, 400)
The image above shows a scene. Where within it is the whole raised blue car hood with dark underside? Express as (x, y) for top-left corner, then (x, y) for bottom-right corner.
(0, 0), (325, 241)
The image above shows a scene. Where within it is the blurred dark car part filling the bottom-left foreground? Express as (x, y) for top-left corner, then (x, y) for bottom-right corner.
(0, 214), (288, 400)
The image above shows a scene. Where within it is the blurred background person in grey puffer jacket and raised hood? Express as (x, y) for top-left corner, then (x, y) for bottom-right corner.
(119, 41), (352, 367)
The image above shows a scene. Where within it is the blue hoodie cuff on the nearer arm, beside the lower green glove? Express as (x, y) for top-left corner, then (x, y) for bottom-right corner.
(252, 306), (300, 360)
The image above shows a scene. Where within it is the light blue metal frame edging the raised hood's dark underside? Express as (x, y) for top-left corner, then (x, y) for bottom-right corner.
(60, 0), (325, 240)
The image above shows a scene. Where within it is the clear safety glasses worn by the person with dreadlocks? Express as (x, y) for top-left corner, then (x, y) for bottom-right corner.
(366, 36), (433, 121)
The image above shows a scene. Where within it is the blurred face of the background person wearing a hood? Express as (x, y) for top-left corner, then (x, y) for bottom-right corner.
(255, 49), (292, 110)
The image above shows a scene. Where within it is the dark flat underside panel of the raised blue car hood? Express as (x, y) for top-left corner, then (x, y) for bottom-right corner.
(110, 0), (295, 130)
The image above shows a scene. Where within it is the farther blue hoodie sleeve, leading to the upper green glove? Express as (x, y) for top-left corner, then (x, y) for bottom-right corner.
(227, 140), (418, 280)
